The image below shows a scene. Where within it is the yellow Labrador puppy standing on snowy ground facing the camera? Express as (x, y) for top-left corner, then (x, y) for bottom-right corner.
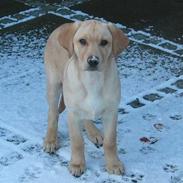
(44, 20), (128, 176)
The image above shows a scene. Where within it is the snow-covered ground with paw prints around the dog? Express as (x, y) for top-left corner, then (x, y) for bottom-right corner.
(0, 14), (183, 183)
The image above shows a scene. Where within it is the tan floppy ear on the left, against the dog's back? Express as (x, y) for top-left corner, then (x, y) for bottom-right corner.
(58, 22), (80, 57)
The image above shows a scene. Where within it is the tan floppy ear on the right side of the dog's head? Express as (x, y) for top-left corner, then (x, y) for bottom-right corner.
(108, 23), (129, 57)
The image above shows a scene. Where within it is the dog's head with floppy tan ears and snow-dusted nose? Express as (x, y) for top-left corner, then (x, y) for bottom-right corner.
(59, 20), (128, 71)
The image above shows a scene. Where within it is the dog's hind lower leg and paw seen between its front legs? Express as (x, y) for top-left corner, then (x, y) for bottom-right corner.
(84, 120), (103, 148)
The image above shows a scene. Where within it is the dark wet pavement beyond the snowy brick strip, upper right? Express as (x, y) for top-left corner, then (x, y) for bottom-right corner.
(71, 0), (183, 44)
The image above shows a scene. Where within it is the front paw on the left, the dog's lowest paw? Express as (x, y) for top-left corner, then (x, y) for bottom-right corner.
(69, 162), (85, 177)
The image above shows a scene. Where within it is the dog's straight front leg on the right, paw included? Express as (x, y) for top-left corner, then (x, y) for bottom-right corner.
(103, 111), (124, 175)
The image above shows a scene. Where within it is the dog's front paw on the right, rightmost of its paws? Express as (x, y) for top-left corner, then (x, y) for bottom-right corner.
(106, 161), (125, 175)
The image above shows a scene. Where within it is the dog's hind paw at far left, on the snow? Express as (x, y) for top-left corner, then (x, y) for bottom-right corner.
(43, 139), (58, 153)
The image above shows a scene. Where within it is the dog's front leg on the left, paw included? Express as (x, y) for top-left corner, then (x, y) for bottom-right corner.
(68, 112), (85, 177)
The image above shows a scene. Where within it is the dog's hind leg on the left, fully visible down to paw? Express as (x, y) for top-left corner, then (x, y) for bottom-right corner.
(44, 82), (62, 153)
